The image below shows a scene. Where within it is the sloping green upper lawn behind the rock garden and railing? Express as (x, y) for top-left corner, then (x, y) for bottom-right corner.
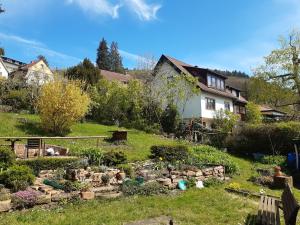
(0, 113), (176, 161)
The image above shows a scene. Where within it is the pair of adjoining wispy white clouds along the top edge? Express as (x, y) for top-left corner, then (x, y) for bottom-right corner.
(66, 0), (161, 21)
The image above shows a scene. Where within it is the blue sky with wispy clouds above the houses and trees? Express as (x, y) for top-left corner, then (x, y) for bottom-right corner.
(0, 0), (300, 73)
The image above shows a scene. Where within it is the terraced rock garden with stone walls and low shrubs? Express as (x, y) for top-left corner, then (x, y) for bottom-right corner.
(0, 145), (234, 212)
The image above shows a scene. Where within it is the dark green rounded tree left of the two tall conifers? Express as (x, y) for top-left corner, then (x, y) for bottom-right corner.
(65, 58), (100, 90)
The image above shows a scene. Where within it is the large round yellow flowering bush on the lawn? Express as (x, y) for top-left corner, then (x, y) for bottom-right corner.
(38, 80), (90, 135)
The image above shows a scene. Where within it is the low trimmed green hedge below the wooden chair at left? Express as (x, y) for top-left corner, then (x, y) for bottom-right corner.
(17, 158), (80, 173)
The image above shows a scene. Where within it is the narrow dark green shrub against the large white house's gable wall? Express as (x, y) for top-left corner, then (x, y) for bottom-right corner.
(161, 104), (179, 133)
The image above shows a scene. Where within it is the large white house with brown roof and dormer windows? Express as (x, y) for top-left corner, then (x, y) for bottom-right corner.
(154, 55), (247, 127)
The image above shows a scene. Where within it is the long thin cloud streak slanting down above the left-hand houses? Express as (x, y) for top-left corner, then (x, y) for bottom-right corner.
(0, 32), (82, 66)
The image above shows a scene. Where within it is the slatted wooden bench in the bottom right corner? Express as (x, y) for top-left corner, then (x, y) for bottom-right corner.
(256, 185), (299, 225)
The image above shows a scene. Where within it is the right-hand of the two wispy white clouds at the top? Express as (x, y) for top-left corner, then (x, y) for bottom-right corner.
(125, 0), (161, 21)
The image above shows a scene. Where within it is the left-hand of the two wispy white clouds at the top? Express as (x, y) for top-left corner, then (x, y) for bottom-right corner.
(67, 0), (121, 18)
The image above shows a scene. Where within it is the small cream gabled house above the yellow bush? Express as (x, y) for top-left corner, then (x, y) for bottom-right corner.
(9, 59), (54, 85)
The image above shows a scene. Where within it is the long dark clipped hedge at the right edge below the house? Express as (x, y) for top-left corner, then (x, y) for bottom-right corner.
(227, 122), (300, 155)
